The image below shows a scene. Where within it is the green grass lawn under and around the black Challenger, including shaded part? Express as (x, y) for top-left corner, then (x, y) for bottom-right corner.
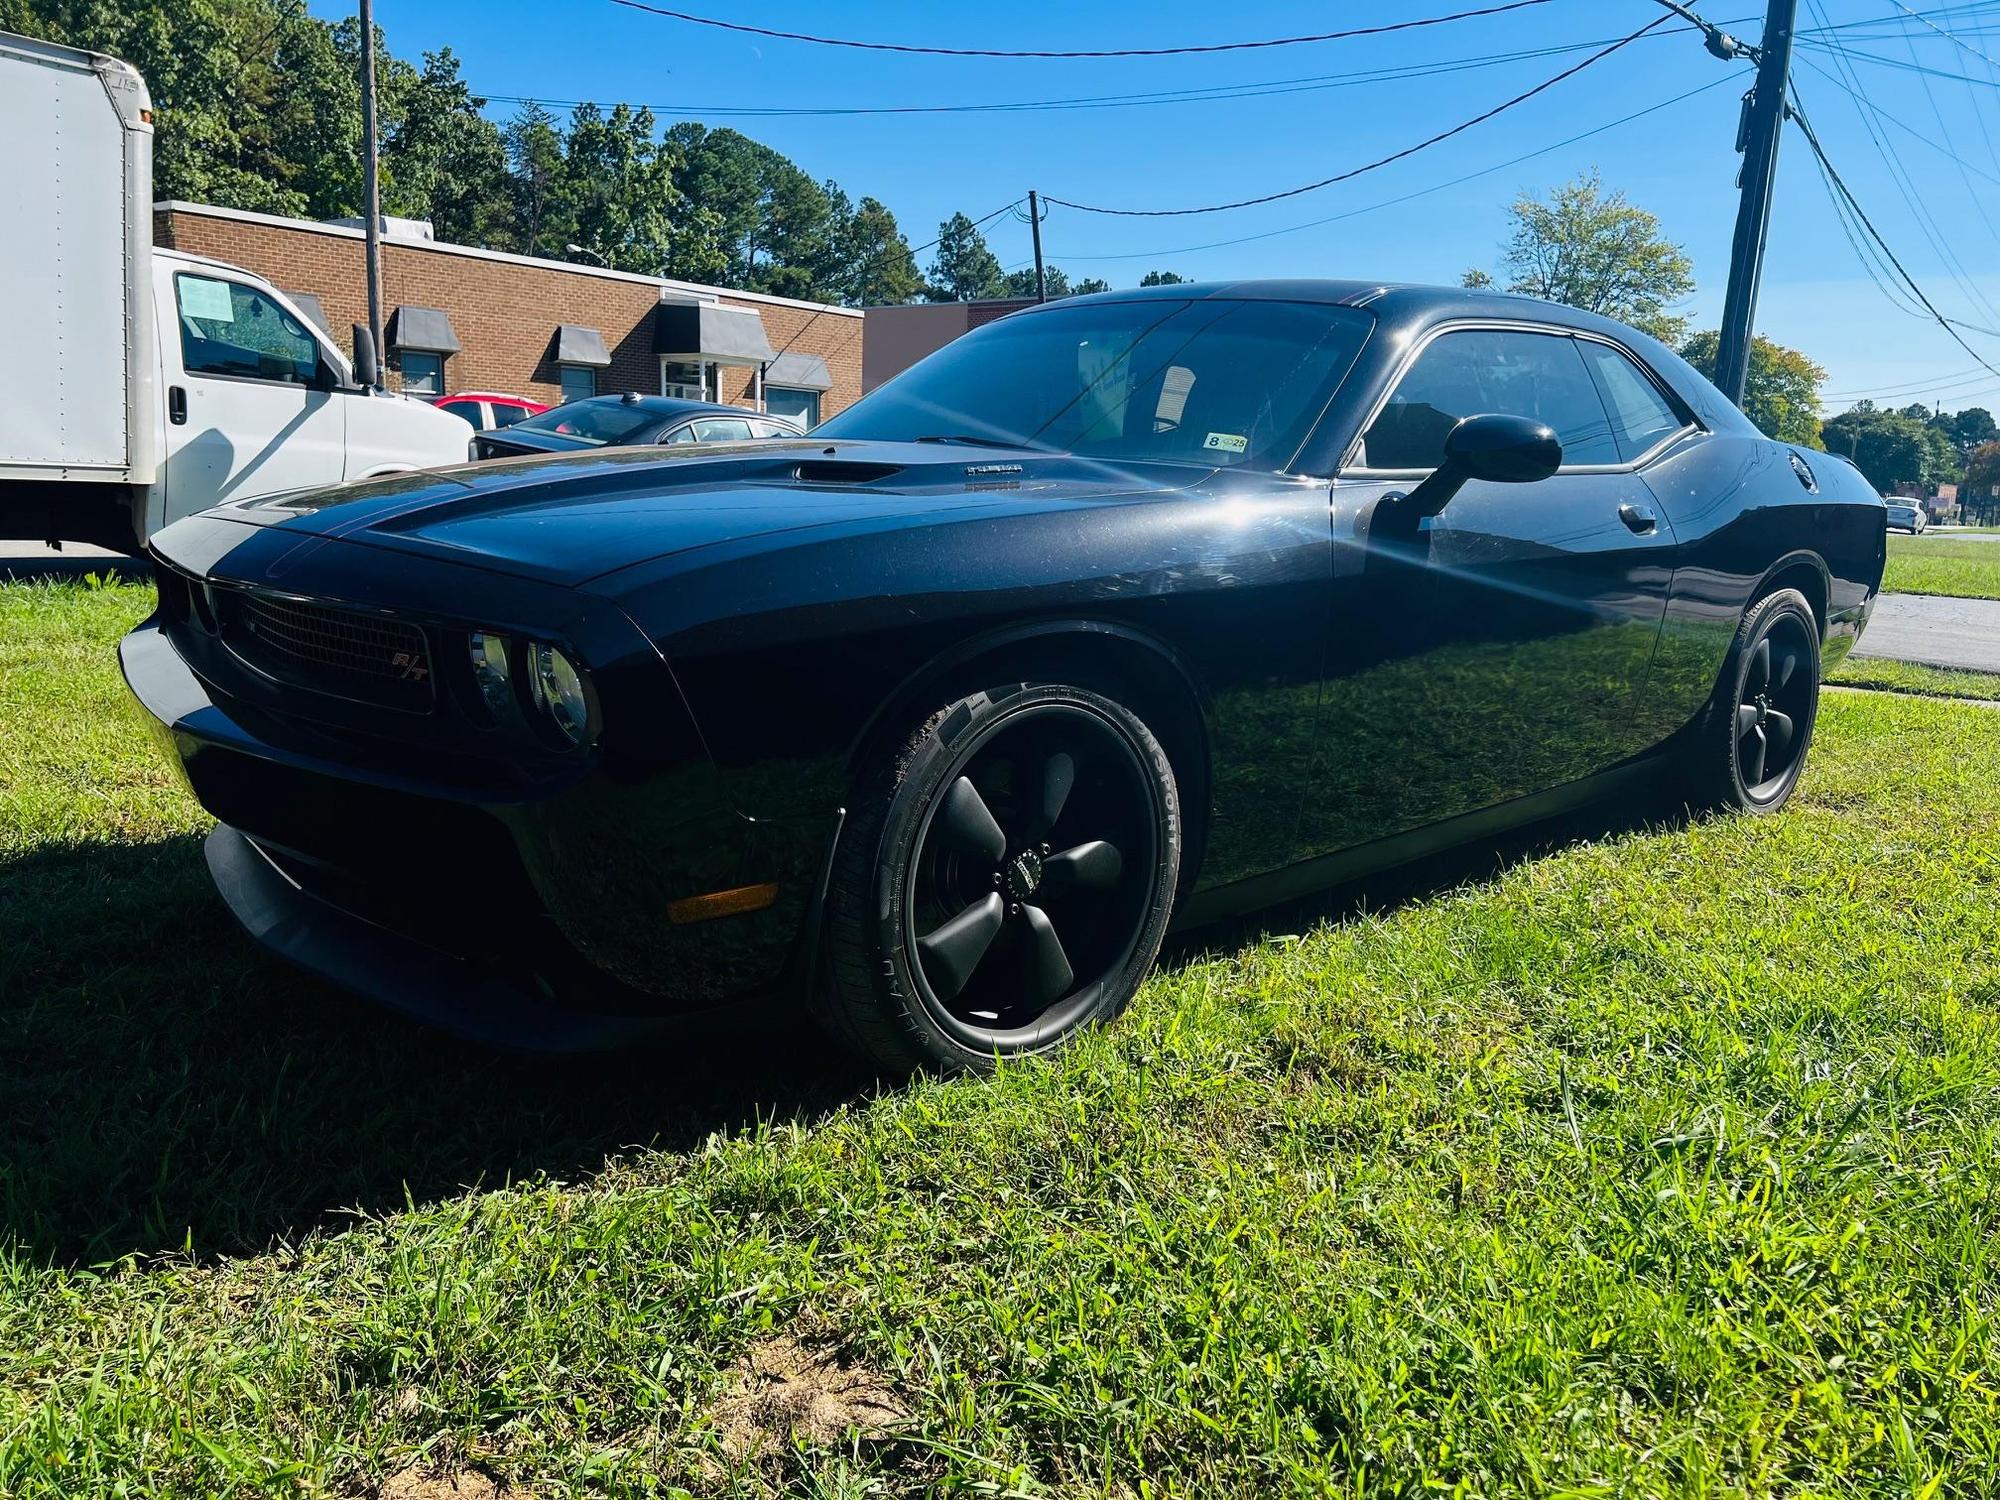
(0, 588), (2000, 1500)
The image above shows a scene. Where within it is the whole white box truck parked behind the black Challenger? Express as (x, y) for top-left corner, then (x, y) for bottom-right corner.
(0, 32), (466, 550)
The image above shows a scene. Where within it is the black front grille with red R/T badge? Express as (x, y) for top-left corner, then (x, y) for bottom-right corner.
(218, 590), (436, 712)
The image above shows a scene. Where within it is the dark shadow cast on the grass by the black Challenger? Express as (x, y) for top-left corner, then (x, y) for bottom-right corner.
(0, 788), (1674, 1264)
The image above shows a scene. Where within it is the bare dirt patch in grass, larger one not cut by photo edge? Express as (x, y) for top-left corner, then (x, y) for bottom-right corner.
(716, 1334), (910, 1462)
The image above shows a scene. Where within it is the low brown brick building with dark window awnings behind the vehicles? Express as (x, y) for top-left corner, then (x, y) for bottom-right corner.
(141, 202), (862, 426)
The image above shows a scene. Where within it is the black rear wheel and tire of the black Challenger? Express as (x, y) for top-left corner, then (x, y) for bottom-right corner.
(1684, 588), (1820, 814)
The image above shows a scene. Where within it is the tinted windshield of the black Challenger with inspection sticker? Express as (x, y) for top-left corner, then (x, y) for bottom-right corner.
(814, 298), (1374, 468)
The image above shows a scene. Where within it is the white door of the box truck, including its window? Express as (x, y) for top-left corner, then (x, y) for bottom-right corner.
(160, 266), (346, 520)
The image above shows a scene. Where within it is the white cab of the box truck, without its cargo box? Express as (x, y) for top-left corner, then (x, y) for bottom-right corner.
(138, 250), (466, 536)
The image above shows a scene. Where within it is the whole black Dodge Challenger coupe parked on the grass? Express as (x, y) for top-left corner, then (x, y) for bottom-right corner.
(122, 282), (1884, 1068)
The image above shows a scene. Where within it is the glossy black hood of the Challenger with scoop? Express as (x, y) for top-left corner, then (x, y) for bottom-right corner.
(180, 438), (1214, 586)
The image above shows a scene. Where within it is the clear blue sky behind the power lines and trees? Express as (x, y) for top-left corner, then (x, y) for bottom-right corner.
(314, 0), (2000, 408)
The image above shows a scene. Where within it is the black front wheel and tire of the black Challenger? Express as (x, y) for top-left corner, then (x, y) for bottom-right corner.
(816, 684), (1182, 1072)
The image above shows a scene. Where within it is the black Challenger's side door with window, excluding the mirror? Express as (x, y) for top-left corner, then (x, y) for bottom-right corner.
(1304, 326), (1674, 856)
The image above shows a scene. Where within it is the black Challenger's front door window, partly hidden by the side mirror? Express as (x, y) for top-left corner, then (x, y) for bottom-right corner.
(1362, 328), (1620, 470)
